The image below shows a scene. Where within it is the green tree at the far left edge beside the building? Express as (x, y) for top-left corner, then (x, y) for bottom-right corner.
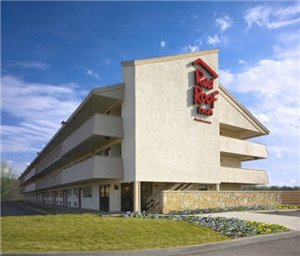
(1, 161), (21, 201)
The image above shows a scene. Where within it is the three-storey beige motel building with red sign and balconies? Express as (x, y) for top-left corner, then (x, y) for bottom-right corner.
(19, 50), (269, 212)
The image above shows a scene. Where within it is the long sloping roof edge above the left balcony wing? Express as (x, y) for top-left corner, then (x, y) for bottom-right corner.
(19, 83), (124, 179)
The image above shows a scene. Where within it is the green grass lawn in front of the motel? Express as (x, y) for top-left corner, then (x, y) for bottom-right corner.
(1, 214), (229, 252)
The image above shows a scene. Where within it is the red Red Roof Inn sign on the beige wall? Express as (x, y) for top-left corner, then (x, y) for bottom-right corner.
(193, 58), (219, 116)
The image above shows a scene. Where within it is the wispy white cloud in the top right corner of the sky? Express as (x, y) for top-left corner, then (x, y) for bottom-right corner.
(244, 3), (300, 29)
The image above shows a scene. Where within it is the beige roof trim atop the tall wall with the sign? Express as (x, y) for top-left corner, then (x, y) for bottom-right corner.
(121, 49), (219, 67)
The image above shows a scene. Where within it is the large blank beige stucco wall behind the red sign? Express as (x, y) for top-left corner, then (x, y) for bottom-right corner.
(131, 52), (220, 183)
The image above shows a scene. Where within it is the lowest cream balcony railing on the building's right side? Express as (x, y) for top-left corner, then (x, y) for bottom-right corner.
(221, 167), (268, 184)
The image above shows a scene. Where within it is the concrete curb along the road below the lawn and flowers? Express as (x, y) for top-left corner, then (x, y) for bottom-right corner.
(4, 231), (300, 256)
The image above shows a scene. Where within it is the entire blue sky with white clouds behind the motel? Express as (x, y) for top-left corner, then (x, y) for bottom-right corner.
(1, 1), (300, 185)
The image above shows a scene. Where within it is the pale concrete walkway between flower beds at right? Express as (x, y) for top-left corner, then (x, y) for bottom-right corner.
(197, 212), (300, 231)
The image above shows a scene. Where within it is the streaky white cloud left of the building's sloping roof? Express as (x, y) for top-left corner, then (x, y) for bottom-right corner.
(1, 76), (86, 156)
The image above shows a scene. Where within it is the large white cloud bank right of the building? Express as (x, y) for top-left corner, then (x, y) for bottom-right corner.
(219, 44), (300, 185)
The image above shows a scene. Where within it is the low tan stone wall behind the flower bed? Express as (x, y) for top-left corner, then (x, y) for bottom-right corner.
(161, 191), (282, 213)
